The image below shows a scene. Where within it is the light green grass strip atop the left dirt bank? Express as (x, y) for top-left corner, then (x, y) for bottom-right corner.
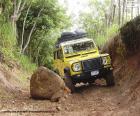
(0, 21), (37, 72)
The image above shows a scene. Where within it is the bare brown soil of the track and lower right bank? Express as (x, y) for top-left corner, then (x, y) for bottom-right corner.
(0, 50), (140, 116)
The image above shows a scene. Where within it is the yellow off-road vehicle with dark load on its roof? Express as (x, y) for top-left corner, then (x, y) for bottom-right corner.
(54, 32), (115, 91)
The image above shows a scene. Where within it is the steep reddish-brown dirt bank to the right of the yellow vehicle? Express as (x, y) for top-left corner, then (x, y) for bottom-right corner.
(102, 16), (140, 111)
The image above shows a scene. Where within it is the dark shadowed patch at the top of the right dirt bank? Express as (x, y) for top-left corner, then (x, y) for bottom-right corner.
(120, 16), (140, 55)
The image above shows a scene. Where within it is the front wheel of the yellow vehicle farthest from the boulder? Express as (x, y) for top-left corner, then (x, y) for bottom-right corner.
(105, 71), (115, 86)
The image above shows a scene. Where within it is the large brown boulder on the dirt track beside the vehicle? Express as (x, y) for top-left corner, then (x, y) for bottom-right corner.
(30, 67), (70, 101)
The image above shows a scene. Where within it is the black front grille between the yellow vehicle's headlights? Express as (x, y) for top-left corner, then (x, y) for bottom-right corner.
(82, 58), (102, 71)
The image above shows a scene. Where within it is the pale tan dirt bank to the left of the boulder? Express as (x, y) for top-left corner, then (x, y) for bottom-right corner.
(0, 63), (29, 99)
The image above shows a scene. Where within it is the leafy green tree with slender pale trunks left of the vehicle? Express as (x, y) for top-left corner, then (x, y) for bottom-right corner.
(17, 0), (70, 65)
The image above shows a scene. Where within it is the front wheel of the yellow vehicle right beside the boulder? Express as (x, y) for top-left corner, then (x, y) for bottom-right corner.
(64, 76), (75, 93)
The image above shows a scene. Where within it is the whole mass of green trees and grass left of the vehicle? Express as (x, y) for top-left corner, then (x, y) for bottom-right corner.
(0, 0), (70, 71)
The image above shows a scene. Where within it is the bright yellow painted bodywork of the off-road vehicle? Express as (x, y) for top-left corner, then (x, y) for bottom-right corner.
(54, 38), (111, 77)
